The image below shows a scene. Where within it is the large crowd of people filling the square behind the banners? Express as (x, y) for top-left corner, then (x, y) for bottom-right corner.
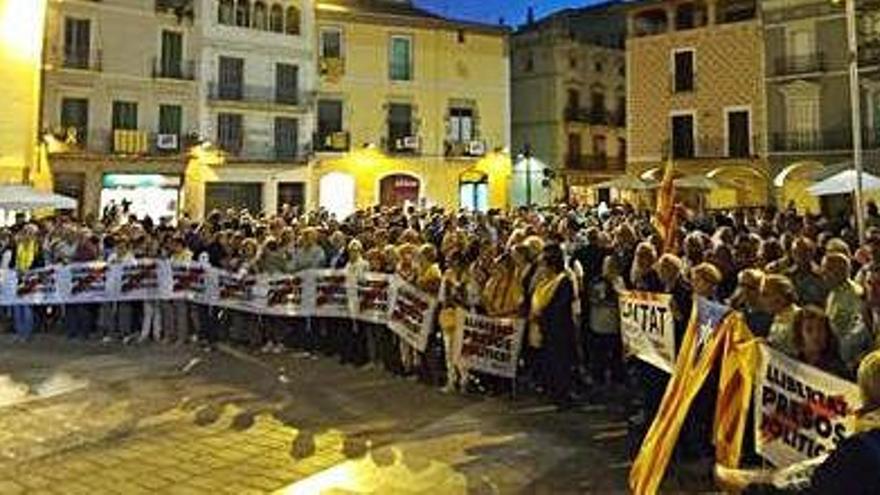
(0, 200), (880, 490)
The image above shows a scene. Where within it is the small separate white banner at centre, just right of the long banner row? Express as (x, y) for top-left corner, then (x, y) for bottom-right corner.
(453, 309), (525, 379)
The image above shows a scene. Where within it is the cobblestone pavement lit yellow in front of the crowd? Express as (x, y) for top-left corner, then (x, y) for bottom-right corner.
(0, 337), (628, 495)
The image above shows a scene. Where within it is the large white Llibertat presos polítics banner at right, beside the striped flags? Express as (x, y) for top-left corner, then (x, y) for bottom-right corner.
(754, 344), (861, 467)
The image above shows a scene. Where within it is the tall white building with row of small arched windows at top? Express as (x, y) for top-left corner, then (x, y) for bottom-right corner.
(187, 0), (317, 216)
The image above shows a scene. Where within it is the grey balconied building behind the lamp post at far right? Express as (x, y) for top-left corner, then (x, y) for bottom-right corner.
(761, 0), (880, 212)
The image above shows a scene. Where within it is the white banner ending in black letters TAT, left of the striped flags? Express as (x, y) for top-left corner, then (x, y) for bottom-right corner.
(620, 291), (675, 373)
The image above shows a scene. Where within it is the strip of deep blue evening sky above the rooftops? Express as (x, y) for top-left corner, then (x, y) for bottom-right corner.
(415, 0), (597, 26)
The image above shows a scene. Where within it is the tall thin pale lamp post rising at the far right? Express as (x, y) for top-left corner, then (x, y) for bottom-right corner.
(834, 0), (865, 243)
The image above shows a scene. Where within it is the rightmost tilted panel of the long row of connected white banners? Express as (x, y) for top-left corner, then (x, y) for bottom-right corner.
(387, 279), (437, 351)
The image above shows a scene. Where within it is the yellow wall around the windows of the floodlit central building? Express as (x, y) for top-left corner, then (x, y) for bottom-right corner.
(311, 5), (511, 208)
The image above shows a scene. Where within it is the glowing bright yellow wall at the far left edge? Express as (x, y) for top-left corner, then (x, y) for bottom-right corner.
(0, 0), (46, 183)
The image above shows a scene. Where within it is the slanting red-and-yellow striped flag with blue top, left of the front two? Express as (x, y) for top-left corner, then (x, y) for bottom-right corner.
(629, 297), (737, 495)
